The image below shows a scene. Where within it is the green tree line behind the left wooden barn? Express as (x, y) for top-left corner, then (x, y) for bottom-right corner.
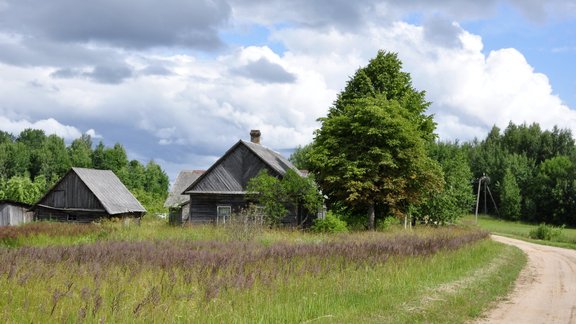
(0, 129), (169, 212)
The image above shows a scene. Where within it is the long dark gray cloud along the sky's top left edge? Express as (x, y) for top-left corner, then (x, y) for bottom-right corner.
(0, 0), (231, 50)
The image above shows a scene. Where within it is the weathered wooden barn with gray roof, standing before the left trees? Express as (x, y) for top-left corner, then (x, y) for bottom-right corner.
(33, 168), (146, 223)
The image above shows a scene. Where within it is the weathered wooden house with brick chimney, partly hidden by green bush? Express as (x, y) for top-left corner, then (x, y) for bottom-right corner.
(183, 130), (306, 225)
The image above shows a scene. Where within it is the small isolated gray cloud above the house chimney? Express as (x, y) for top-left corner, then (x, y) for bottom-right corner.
(232, 58), (296, 83)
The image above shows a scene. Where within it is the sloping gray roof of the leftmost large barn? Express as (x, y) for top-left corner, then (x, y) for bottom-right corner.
(72, 168), (146, 215)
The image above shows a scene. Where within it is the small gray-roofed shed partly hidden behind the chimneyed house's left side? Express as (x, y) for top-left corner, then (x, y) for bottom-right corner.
(164, 170), (204, 225)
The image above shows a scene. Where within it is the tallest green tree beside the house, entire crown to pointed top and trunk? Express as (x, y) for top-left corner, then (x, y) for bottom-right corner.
(308, 51), (443, 228)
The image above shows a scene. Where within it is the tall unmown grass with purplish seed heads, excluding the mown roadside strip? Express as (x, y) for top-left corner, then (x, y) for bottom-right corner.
(0, 228), (506, 322)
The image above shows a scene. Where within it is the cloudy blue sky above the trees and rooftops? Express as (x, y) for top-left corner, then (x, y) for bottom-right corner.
(0, 0), (576, 181)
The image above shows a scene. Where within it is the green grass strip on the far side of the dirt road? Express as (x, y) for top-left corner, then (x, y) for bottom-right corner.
(461, 215), (576, 249)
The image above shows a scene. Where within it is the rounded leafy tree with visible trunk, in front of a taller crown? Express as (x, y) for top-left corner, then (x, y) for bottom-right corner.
(310, 96), (443, 229)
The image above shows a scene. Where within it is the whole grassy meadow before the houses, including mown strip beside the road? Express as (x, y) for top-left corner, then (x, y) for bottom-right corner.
(0, 220), (525, 323)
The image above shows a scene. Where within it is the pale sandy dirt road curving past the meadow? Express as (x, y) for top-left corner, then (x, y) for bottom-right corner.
(478, 235), (576, 323)
